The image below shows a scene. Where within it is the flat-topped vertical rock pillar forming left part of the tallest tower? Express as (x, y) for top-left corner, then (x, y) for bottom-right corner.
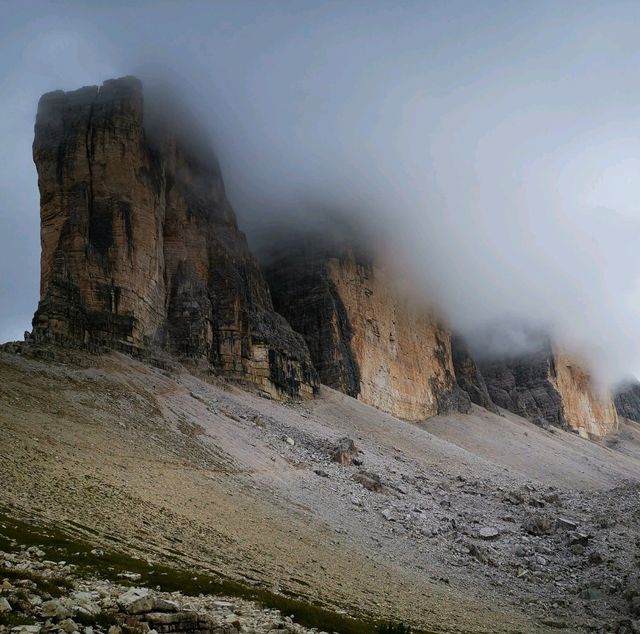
(33, 79), (165, 349)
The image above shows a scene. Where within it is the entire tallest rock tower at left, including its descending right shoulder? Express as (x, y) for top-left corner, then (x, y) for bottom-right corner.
(33, 77), (317, 396)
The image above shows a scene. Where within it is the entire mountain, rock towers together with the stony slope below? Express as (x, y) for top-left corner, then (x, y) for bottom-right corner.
(0, 77), (640, 634)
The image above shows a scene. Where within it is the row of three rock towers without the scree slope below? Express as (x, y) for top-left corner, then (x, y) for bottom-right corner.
(28, 77), (617, 437)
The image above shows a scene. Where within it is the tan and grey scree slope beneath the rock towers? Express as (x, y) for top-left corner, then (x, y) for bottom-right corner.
(0, 350), (640, 633)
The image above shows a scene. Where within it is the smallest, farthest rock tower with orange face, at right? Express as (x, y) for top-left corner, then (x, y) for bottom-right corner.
(480, 345), (618, 437)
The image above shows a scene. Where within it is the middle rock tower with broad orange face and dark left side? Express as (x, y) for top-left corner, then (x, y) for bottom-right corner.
(266, 243), (469, 420)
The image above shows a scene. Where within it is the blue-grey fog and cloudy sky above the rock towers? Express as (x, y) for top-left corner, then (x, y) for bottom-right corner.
(0, 0), (640, 385)
